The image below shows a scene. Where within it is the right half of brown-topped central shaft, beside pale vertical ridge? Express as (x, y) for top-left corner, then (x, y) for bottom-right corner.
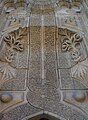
(44, 26), (58, 87)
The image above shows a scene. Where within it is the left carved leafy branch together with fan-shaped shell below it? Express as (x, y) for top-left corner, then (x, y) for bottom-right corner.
(0, 28), (27, 80)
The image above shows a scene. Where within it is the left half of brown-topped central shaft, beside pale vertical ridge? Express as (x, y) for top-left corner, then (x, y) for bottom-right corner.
(27, 26), (42, 86)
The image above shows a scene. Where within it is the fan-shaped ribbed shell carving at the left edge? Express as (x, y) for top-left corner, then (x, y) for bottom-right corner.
(0, 63), (16, 80)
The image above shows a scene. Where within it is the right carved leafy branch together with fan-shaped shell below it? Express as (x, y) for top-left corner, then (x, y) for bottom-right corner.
(61, 30), (88, 79)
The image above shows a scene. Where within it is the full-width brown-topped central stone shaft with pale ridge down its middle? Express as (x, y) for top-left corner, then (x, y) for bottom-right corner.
(27, 26), (58, 87)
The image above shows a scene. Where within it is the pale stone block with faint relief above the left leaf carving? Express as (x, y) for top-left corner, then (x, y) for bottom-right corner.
(2, 9), (30, 34)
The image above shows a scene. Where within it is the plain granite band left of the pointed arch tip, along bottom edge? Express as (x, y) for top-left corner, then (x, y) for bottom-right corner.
(2, 103), (42, 120)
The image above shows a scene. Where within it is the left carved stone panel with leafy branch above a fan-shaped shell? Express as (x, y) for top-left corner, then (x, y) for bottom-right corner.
(0, 28), (29, 90)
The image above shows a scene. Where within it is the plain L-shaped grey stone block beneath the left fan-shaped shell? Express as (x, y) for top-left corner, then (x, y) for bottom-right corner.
(0, 69), (27, 91)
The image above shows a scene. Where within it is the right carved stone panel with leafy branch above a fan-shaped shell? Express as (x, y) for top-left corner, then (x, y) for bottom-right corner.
(58, 28), (88, 89)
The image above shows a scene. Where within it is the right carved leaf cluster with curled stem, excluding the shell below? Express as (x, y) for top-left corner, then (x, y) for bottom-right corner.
(61, 30), (83, 62)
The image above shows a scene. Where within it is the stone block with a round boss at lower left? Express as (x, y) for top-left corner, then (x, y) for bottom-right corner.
(0, 91), (24, 113)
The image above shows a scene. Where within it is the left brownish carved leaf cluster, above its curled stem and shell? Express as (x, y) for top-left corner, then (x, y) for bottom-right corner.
(3, 28), (27, 52)
